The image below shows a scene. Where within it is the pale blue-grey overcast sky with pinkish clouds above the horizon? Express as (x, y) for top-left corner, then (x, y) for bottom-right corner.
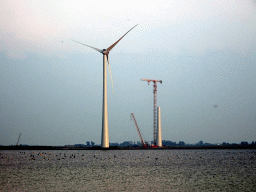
(0, 0), (256, 145)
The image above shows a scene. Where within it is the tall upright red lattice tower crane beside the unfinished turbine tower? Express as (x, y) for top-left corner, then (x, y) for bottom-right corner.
(141, 79), (162, 145)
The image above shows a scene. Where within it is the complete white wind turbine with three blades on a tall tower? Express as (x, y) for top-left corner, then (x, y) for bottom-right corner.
(72, 24), (138, 148)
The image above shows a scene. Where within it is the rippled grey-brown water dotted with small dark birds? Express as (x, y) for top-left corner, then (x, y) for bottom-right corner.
(0, 150), (256, 191)
